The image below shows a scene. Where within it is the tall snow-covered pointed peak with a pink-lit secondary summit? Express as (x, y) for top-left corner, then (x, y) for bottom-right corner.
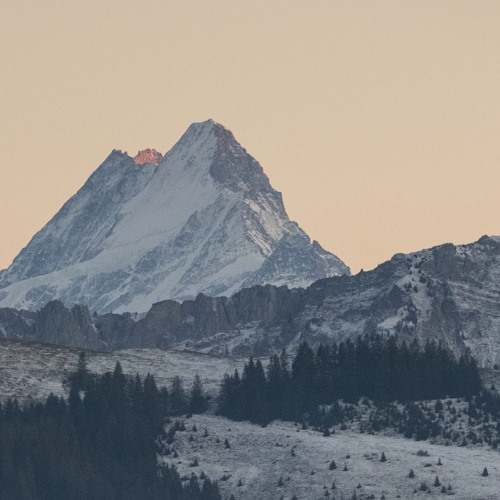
(0, 120), (349, 313)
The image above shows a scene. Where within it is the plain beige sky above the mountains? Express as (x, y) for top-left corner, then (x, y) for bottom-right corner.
(0, 0), (500, 272)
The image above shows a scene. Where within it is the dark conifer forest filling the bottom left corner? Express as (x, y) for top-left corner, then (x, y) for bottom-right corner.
(0, 356), (220, 500)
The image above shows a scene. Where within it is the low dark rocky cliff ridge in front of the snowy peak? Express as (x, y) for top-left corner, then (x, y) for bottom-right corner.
(0, 236), (500, 367)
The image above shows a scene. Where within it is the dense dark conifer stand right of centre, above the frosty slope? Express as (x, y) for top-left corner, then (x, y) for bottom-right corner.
(217, 335), (481, 424)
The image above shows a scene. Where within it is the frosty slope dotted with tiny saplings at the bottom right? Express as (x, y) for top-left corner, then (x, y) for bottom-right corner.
(165, 415), (500, 500)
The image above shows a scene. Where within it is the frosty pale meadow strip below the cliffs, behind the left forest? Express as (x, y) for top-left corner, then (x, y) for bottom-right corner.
(0, 340), (244, 401)
